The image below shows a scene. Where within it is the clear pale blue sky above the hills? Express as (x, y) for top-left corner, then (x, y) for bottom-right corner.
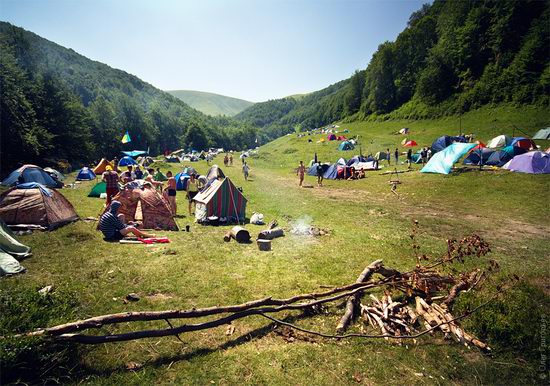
(0, 0), (428, 102)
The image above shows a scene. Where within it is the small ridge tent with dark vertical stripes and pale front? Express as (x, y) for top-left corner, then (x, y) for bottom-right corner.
(194, 178), (247, 222)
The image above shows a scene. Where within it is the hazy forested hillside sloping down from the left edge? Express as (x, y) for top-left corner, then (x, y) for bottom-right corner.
(0, 22), (257, 174)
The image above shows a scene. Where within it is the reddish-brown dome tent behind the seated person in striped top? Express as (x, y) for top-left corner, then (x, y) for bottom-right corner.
(110, 184), (178, 231)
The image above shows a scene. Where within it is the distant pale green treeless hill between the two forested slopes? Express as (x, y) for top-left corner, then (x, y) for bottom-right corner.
(166, 90), (254, 116)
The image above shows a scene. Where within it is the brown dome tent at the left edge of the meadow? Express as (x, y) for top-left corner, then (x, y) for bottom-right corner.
(0, 183), (78, 230)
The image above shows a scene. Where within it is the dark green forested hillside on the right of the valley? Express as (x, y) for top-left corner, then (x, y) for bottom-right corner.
(236, 0), (550, 135)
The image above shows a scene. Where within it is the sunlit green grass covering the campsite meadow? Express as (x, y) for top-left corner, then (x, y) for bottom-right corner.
(0, 107), (550, 385)
